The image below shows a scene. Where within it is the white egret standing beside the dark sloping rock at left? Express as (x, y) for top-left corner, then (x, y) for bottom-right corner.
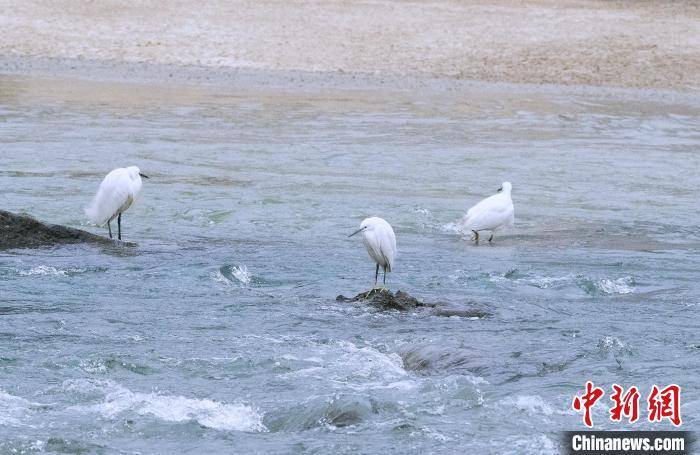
(85, 166), (148, 240)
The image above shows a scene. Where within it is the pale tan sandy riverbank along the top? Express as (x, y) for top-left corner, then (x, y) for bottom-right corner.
(0, 0), (700, 90)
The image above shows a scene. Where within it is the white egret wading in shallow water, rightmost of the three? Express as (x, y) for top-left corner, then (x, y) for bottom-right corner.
(461, 182), (515, 243)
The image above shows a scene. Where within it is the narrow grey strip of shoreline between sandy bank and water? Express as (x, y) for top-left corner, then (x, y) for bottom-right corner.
(0, 56), (700, 105)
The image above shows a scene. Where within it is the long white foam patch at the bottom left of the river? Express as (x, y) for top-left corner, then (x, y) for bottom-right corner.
(68, 381), (267, 431)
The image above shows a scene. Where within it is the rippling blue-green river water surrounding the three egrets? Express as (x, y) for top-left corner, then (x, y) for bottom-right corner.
(0, 78), (700, 454)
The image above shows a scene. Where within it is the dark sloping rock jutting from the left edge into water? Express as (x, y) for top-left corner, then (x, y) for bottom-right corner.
(0, 210), (112, 250)
